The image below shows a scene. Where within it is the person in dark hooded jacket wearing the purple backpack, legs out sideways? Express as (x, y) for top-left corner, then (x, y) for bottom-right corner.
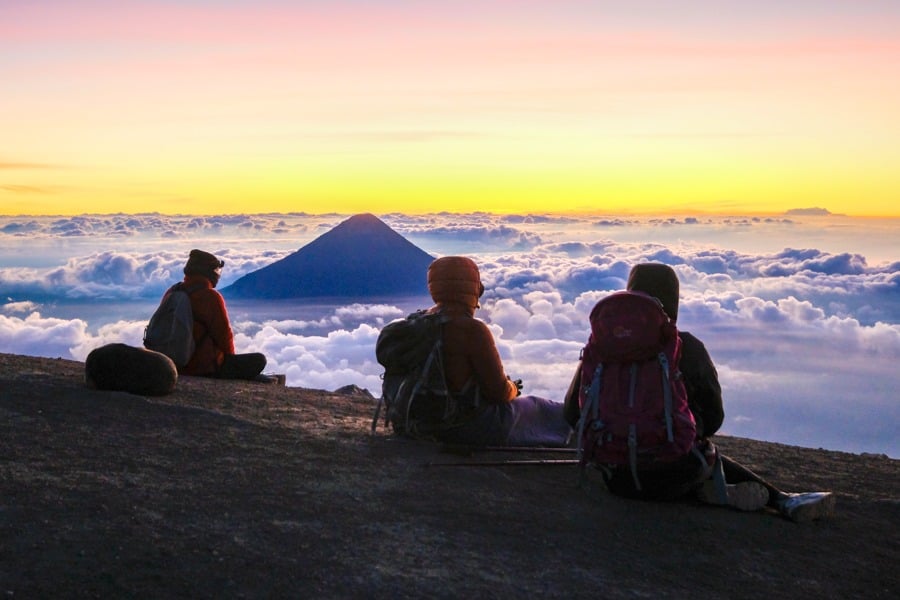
(565, 263), (834, 521)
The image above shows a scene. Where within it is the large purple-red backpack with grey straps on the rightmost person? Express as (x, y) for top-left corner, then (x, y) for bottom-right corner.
(578, 291), (697, 489)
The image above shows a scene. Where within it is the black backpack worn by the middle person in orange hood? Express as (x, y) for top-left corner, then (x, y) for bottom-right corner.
(372, 310), (460, 438)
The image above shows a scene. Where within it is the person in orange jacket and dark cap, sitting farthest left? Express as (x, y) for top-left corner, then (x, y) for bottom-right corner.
(171, 249), (266, 379)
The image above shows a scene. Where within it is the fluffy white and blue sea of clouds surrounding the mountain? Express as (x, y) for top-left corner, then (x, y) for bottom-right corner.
(0, 213), (900, 457)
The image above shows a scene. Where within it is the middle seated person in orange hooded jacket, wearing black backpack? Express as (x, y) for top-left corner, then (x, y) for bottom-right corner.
(420, 256), (571, 446)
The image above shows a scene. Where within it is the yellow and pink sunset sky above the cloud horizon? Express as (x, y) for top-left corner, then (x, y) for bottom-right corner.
(0, 0), (900, 217)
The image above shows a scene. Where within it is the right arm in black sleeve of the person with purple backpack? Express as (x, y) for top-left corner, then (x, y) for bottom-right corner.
(680, 331), (725, 437)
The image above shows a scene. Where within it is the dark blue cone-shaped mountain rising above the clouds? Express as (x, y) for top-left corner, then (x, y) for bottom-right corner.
(222, 213), (434, 299)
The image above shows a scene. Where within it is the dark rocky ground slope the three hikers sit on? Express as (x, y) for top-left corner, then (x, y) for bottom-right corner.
(0, 354), (900, 599)
